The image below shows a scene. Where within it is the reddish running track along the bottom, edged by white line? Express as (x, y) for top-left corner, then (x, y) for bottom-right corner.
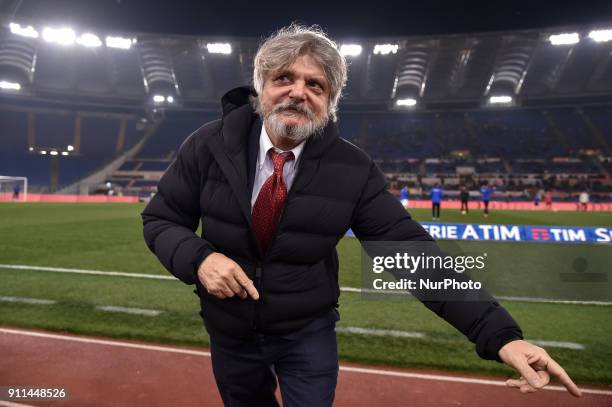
(0, 327), (612, 407)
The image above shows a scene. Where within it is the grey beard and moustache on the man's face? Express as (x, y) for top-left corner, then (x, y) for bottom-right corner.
(251, 98), (329, 143)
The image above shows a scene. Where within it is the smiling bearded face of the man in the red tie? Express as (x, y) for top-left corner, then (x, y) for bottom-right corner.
(259, 54), (330, 142)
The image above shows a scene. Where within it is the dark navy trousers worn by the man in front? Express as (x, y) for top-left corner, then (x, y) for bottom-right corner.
(210, 321), (338, 407)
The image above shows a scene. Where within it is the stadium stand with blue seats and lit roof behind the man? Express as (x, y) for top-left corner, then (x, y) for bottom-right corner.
(0, 18), (612, 200)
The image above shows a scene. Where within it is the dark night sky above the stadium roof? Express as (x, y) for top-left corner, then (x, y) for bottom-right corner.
(7, 0), (612, 38)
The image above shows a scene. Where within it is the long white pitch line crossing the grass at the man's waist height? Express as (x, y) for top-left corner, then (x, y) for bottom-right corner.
(0, 264), (612, 306)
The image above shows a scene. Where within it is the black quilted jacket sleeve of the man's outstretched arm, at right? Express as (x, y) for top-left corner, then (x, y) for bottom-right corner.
(352, 163), (523, 362)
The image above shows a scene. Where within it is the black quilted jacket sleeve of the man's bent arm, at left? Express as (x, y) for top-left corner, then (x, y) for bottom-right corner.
(141, 133), (214, 284)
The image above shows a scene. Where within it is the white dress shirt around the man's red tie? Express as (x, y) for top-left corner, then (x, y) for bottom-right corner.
(251, 126), (304, 209)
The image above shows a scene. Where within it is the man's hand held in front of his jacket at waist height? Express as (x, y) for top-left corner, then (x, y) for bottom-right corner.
(198, 253), (259, 300)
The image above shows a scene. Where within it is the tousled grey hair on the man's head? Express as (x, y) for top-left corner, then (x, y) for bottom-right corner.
(253, 23), (347, 121)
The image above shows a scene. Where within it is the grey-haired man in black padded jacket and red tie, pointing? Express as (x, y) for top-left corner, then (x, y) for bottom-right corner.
(142, 25), (579, 407)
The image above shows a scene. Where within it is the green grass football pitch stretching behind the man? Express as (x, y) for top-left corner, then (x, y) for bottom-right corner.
(0, 203), (612, 384)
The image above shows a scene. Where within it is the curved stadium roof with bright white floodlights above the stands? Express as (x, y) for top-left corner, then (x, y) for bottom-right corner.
(0, 0), (612, 110)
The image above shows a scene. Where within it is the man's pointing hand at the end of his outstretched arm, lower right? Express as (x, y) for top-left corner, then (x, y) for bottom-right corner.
(499, 340), (582, 397)
